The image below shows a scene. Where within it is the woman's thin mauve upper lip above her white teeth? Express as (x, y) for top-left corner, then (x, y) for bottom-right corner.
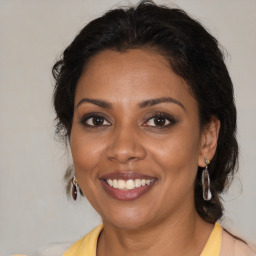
(100, 172), (156, 180)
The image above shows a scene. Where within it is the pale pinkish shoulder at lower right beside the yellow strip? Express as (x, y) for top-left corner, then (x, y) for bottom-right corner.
(220, 229), (256, 256)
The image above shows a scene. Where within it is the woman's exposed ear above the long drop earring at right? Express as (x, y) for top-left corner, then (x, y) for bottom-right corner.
(198, 117), (220, 167)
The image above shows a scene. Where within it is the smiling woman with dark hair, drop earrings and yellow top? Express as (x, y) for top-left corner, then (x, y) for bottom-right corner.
(53, 1), (253, 256)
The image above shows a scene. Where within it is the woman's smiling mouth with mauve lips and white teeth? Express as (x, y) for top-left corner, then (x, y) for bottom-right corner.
(100, 173), (157, 201)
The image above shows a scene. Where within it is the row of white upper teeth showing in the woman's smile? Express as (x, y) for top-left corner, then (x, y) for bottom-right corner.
(107, 179), (154, 190)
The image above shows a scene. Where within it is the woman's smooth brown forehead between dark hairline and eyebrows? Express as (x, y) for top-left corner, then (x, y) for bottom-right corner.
(75, 49), (195, 108)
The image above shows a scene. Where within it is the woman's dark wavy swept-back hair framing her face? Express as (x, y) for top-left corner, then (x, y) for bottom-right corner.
(52, 0), (238, 223)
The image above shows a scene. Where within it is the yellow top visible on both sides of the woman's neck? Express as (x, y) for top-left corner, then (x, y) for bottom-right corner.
(63, 222), (222, 256)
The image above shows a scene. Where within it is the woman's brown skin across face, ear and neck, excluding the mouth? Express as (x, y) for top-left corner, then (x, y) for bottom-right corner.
(70, 49), (220, 256)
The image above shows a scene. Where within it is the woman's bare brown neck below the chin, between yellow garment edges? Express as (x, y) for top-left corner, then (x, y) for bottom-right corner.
(97, 205), (213, 256)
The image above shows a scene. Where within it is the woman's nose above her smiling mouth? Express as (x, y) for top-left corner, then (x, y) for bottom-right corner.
(107, 125), (146, 164)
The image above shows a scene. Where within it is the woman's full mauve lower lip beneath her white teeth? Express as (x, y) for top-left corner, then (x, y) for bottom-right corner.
(100, 179), (155, 201)
